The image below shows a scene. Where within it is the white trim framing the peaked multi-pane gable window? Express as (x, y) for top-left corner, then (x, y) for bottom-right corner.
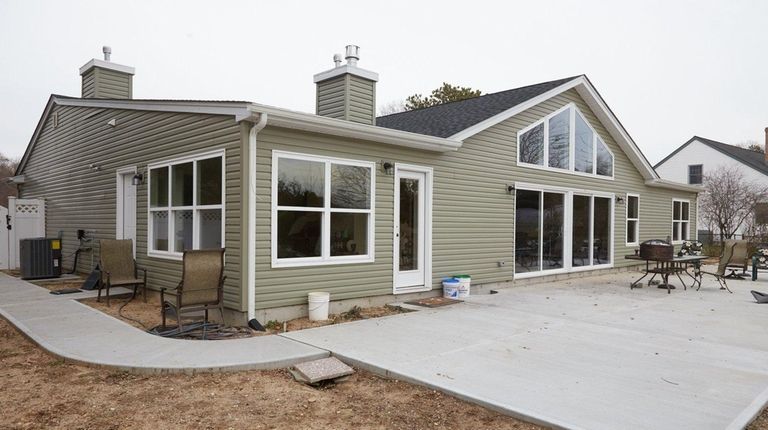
(516, 102), (616, 181)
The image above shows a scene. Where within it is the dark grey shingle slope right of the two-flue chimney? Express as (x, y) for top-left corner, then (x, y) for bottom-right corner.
(376, 76), (578, 137)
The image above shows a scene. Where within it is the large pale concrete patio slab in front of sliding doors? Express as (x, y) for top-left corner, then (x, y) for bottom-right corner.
(283, 273), (768, 430)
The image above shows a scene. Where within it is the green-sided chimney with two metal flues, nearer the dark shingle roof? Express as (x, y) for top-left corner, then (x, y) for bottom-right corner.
(314, 45), (379, 125)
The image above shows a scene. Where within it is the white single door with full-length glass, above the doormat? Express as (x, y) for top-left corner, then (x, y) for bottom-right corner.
(394, 165), (432, 294)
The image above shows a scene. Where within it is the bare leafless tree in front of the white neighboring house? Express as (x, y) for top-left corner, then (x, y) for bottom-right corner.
(699, 166), (768, 238)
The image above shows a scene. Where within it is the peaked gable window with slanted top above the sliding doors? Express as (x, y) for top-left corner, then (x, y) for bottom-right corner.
(517, 103), (614, 178)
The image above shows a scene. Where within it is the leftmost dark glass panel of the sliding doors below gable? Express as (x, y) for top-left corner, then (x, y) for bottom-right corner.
(515, 190), (541, 273)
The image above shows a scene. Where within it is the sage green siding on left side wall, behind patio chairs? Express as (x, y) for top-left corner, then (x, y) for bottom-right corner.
(20, 106), (244, 310)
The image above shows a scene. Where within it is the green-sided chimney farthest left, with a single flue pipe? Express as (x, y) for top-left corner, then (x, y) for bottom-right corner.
(80, 46), (134, 99)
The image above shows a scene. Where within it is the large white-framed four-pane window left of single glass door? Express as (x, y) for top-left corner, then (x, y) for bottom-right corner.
(272, 151), (375, 266)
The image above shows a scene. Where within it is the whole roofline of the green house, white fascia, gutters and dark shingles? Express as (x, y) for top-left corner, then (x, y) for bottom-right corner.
(16, 75), (698, 192)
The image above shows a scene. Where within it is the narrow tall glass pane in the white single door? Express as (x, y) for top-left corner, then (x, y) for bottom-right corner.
(399, 178), (421, 272)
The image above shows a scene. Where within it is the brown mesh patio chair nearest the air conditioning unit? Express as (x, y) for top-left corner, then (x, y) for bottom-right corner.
(96, 239), (147, 306)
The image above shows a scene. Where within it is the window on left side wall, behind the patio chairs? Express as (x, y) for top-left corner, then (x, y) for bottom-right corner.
(148, 151), (224, 257)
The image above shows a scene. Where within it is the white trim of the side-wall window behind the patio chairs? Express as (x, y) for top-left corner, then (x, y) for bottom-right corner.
(147, 149), (227, 260)
